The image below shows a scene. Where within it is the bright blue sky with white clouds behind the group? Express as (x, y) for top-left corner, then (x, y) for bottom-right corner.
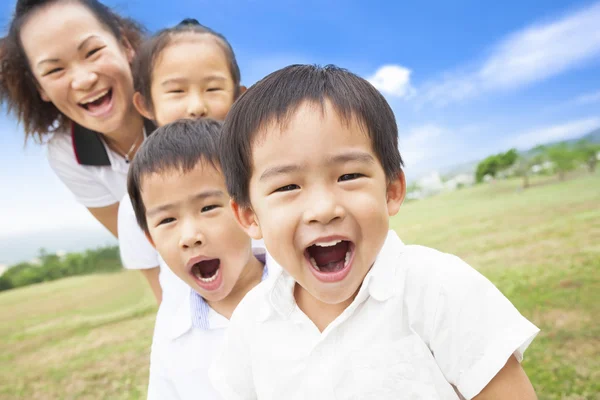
(0, 0), (600, 261)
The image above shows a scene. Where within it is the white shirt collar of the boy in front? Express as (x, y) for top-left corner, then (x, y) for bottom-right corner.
(257, 230), (404, 321)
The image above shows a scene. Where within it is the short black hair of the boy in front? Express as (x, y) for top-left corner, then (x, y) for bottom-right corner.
(220, 64), (403, 207)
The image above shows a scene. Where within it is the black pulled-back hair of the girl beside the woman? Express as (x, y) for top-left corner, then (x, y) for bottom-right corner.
(131, 18), (242, 109)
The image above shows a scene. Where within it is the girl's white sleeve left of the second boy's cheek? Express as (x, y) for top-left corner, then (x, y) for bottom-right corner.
(118, 195), (160, 269)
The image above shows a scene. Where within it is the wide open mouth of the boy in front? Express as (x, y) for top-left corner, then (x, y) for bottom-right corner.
(304, 239), (355, 280)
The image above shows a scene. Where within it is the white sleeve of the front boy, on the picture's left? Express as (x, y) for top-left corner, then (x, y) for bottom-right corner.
(209, 296), (257, 400)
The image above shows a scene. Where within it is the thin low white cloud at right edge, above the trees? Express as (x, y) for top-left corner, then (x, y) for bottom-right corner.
(506, 117), (600, 150)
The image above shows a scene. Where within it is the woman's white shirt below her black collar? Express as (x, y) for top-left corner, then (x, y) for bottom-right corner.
(47, 133), (129, 207)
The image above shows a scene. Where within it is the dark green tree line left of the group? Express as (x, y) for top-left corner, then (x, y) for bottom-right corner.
(0, 246), (121, 291)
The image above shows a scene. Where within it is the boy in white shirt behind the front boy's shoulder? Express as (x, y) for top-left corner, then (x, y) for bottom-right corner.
(127, 119), (274, 399)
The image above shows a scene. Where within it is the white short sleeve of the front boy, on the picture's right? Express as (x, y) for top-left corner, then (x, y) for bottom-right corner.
(422, 255), (539, 399)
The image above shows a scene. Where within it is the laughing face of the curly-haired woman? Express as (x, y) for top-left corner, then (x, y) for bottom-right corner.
(21, 1), (135, 135)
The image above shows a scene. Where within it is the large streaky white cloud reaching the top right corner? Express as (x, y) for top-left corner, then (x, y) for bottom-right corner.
(421, 2), (600, 105)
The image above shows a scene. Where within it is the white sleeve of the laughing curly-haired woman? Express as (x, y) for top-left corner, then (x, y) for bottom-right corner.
(47, 134), (120, 208)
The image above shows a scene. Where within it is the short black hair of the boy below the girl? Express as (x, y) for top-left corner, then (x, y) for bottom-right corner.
(127, 118), (222, 233)
